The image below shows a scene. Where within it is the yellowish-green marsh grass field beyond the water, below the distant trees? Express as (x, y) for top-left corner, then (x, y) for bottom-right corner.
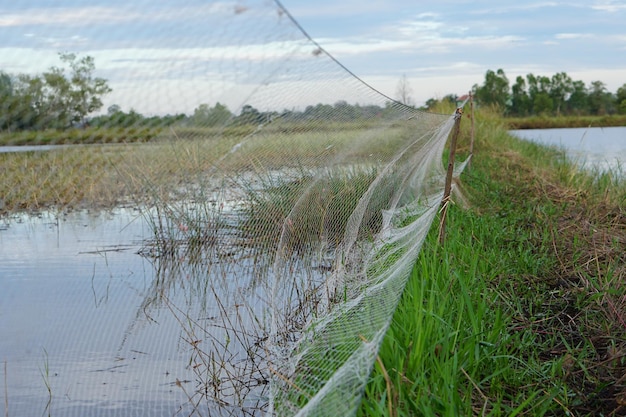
(0, 119), (428, 214)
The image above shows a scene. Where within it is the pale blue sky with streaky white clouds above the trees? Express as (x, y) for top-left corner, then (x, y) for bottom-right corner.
(0, 0), (626, 114)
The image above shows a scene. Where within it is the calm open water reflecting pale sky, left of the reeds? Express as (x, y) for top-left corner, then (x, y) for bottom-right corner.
(0, 209), (260, 416)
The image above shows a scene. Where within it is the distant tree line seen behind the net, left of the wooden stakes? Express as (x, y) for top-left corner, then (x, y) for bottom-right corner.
(0, 53), (412, 132)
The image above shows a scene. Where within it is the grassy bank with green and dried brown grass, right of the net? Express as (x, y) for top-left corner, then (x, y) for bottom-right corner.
(359, 109), (626, 416)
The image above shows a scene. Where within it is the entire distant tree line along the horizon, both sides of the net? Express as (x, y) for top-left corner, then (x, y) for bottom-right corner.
(0, 53), (626, 132)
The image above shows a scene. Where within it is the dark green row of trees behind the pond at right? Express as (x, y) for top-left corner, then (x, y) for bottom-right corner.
(472, 69), (626, 117)
